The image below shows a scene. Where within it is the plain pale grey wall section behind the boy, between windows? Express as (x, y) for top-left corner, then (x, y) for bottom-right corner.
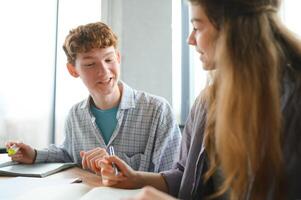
(102, 0), (172, 103)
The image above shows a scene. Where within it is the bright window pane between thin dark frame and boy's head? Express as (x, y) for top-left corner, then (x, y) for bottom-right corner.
(55, 0), (101, 144)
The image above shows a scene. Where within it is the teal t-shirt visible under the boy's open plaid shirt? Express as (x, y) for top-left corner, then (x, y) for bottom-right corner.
(91, 105), (118, 144)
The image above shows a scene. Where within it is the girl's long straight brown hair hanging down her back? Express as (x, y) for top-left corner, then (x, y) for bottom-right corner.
(189, 0), (301, 200)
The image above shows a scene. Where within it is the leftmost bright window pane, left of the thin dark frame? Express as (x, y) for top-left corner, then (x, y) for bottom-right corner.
(0, 0), (56, 147)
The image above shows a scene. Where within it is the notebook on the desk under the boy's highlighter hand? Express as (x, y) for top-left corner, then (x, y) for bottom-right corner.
(0, 162), (76, 178)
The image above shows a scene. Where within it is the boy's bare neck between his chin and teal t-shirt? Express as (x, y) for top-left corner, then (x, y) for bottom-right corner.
(92, 86), (122, 110)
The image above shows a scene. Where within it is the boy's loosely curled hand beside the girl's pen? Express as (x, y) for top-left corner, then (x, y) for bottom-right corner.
(80, 147), (108, 174)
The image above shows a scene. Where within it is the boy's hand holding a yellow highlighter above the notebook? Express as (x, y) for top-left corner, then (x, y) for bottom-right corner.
(5, 142), (36, 164)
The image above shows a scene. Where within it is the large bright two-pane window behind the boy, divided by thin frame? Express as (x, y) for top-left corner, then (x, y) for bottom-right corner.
(0, 0), (101, 148)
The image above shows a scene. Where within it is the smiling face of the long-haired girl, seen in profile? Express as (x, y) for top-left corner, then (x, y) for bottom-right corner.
(187, 4), (218, 70)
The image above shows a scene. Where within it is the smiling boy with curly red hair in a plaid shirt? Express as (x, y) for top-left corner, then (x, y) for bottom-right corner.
(7, 22), (181, 173)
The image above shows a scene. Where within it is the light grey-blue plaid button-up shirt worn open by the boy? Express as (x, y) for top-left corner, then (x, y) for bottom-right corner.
(36, 82), (181, 172)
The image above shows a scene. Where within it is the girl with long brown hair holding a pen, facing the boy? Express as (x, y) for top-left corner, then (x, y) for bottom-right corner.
(99, 0), (301, 200)
